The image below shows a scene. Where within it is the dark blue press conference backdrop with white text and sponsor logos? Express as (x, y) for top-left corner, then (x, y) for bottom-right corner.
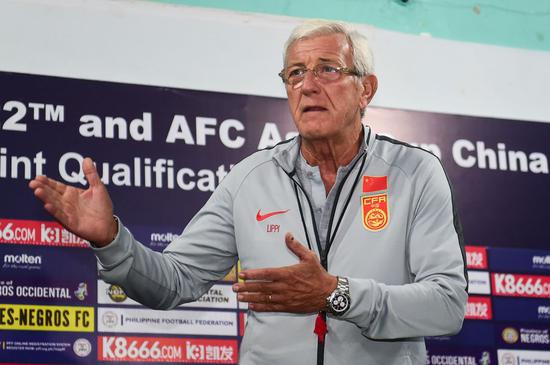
(0, 72), (550, 365)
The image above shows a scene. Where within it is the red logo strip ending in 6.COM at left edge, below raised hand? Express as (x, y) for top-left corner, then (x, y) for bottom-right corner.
(0, 219), (88, 247)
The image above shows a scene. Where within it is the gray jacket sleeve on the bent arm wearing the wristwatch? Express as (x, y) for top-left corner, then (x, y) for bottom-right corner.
(343, 158), (468, 340)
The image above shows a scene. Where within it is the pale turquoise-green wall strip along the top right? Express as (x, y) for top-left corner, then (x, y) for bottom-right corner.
(152, 0), (550, 51)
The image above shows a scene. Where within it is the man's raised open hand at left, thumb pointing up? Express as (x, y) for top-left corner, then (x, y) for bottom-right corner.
(29, 158), (118, 247)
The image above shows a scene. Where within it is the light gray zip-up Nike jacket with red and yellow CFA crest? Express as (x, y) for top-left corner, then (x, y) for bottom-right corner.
(95, 127), (467, 365)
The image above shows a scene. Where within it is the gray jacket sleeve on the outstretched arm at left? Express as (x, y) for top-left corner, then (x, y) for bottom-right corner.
(94, 175), (237, 309)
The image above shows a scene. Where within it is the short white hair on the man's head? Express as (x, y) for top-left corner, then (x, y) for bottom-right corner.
(283, 19), (374, 76)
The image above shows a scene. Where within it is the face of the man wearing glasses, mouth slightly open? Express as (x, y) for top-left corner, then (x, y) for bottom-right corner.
(286, 34), (376, 140)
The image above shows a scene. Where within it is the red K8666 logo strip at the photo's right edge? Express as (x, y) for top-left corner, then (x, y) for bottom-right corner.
(492, 273), (550, 298)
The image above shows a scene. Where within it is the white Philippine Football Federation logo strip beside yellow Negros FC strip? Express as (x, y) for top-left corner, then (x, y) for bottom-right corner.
(98, 308), (237, 336)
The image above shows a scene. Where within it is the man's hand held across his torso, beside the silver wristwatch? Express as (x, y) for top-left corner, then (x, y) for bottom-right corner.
(233, 233), (337, 313)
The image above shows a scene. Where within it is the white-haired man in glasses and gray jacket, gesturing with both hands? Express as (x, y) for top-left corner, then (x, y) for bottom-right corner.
(30, 21), (467, 365)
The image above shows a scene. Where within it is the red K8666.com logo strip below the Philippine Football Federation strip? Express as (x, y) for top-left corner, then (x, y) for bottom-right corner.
(98, 336), (238, 364)
